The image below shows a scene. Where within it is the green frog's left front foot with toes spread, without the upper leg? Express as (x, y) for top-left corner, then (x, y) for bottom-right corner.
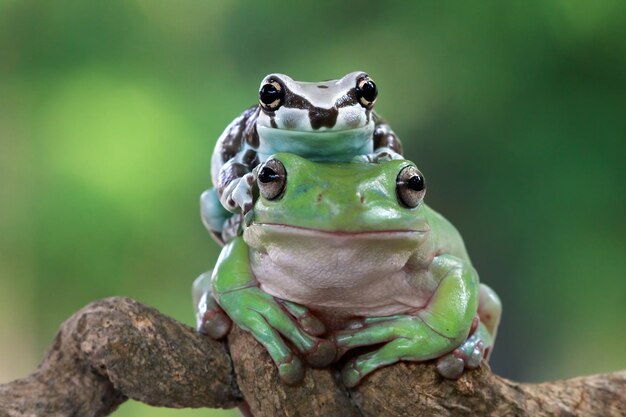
(220, 287), (336, 384)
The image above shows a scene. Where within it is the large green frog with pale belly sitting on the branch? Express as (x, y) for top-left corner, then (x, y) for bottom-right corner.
(194, 153), (501, 387)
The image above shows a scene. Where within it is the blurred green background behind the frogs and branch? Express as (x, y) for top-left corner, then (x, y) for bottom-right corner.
(0, 0), (626, 416)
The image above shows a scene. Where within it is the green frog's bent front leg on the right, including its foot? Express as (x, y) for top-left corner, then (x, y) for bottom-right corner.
(334, 255), (478, 387)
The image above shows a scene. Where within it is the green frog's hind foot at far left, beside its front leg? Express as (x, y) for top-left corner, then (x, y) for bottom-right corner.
(192, 271), (232, 339)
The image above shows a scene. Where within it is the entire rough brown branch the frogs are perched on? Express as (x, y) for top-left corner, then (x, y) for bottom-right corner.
(0, 298), (626, 417)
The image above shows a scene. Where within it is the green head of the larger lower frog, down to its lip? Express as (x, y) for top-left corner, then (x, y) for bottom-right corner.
(244, 153), (429, 248)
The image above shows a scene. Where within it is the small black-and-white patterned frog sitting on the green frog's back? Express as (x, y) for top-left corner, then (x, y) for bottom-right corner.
(201, 71), (402, 241)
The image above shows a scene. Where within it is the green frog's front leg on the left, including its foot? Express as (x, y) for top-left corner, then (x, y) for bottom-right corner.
(211, 237), (336, 383)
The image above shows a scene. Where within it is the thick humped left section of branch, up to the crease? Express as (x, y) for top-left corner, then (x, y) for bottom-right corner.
(0, 298), (241, 417)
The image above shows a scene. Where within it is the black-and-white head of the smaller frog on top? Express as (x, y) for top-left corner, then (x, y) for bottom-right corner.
(252, 71), (378, 160)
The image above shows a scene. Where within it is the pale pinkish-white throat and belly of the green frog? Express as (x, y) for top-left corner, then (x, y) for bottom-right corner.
(244, 224), (437, 321)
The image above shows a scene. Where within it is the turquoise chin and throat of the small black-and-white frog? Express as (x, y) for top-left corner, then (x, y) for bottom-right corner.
(257, 123), (374, 162)
